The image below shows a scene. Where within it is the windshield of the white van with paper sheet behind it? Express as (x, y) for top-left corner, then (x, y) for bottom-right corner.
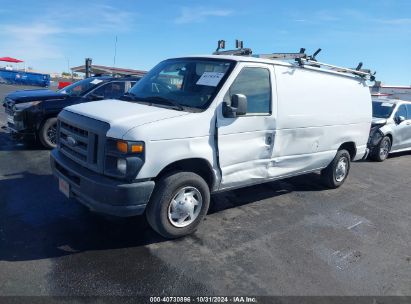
(129, 58), (234, 109)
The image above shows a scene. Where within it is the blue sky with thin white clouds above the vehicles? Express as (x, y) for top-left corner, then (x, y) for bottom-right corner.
(0, 0), (411, 85)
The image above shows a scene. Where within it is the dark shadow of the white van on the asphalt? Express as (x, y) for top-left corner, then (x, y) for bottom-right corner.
(0, 172), (324, 261)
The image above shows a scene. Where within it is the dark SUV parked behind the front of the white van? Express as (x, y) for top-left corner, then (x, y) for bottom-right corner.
(3, 76), (141, 148)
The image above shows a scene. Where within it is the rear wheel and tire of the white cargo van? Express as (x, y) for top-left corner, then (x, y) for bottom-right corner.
(321, 150), (351, 189)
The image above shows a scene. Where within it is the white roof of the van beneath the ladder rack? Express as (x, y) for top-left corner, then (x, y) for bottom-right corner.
(174, 55), (365, 81)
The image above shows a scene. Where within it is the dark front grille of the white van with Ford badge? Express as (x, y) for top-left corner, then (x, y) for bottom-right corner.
(57, 111), (109, 173)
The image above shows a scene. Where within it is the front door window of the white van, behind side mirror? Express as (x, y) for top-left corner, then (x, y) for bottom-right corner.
(224, 68), (271, 114)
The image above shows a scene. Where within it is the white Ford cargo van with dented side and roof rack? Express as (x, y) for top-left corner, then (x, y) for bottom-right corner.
(51, 51), (371, 238)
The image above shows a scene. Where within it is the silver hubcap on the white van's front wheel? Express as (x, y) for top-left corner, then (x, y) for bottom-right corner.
(168, 187), (203, 228)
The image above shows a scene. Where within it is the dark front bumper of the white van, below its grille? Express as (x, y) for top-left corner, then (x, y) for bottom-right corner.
(50, 149), (155, 217)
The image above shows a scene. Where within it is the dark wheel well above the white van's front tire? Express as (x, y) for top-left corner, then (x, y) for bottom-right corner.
(155, 158), (215, 189)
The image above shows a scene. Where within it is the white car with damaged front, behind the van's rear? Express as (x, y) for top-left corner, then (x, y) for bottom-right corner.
(368, 99), (411, 162)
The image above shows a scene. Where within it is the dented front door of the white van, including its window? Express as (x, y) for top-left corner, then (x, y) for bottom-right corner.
(217, 63), (276, 189)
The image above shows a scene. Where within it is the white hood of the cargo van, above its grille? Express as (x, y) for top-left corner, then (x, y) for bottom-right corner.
(65, 99), (189, 137)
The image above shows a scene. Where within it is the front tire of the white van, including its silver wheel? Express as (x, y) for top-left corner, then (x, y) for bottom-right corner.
(146, 172), (210, 239)
